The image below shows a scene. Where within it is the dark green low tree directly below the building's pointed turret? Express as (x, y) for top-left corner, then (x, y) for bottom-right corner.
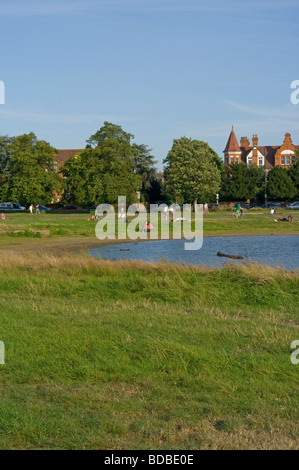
(220, 163), (264, 201)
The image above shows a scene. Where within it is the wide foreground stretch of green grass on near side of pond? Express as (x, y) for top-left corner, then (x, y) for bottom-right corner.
(0, 255), (299, 449)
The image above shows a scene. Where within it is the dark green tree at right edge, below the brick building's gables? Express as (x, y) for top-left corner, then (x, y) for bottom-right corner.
(267, 166), (297, 200)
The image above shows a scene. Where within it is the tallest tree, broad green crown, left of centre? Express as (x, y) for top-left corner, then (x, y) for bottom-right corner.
(63, 122), (141, 207)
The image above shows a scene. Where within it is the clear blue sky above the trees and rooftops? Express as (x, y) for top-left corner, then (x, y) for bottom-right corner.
(0, 0), (299, 168)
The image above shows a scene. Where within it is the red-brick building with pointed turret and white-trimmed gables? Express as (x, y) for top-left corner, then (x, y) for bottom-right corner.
(223, 128), (299, 172)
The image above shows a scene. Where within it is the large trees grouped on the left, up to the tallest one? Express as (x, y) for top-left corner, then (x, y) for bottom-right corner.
(0, 122), (161, 207)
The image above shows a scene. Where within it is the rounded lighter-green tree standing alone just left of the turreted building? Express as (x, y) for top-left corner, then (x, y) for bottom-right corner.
(164, 137), (221, 208)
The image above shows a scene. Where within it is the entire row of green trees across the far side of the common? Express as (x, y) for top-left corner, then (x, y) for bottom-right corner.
(0, 122), (299, 207)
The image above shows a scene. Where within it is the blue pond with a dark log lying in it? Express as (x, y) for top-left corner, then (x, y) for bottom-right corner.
(88, 235), (299, 270)
